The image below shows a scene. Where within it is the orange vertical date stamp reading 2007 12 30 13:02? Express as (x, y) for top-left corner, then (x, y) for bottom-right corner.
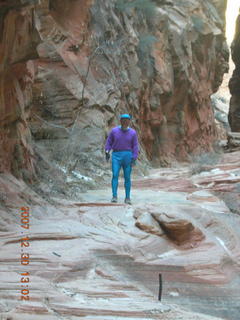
(20, 207), (30, 300)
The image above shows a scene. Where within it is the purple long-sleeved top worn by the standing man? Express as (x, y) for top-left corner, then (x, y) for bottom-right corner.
(105, 127), (139, 159)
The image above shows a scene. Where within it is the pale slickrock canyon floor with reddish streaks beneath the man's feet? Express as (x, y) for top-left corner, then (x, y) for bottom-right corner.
(0, 152), (240, 320)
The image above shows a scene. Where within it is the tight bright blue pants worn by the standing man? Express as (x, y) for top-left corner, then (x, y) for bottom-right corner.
(112, 151), (132, 198)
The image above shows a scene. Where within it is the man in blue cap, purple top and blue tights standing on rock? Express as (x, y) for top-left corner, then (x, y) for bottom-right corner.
(105, 113), (139, 204)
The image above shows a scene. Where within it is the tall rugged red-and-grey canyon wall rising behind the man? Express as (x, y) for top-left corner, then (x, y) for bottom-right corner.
(0, 0), (228, 190)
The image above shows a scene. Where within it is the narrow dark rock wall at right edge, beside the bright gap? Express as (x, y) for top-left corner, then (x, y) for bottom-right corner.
(228, 11), (240, 132)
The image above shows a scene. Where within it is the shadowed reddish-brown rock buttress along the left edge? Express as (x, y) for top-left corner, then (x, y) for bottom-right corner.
(0, 0), (38, 180)
